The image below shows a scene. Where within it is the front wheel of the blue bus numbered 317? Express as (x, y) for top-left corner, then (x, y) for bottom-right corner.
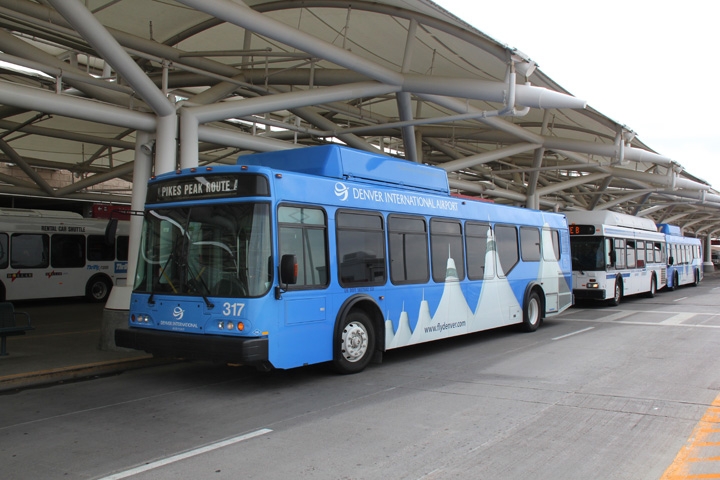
(333, 310), (375, 374)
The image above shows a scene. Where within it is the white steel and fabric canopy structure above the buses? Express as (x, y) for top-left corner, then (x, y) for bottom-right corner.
(0, 0), (720, 249)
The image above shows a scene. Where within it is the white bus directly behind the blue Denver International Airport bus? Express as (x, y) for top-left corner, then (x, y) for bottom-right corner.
(566, 210), (666, 305)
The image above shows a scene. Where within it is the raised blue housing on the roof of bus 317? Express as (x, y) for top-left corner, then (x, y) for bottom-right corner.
(237, 145), (450, 195)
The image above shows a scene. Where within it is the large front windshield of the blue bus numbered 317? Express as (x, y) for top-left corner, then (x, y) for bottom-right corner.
(134, 203), (273, 297)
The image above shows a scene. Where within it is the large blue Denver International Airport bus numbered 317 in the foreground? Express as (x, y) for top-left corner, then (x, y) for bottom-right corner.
(115, 145), (572, 373)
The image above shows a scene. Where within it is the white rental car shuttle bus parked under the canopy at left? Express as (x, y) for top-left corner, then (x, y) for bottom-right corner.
(0, 208), (129, 302)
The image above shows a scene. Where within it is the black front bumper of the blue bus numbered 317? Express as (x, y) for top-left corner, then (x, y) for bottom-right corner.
(115, 328), (269, 369)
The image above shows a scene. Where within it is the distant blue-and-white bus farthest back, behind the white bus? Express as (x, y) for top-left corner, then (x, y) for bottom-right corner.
(657, 223), (703, 290)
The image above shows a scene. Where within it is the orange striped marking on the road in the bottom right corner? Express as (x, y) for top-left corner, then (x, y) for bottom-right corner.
(660, 395), (720, 480)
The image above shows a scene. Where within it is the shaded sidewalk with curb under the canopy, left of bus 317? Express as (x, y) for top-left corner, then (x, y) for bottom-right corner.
(0, 298), (167, 392)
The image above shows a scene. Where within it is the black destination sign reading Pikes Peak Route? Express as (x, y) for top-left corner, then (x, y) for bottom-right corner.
(147, 174), (270, 203)
